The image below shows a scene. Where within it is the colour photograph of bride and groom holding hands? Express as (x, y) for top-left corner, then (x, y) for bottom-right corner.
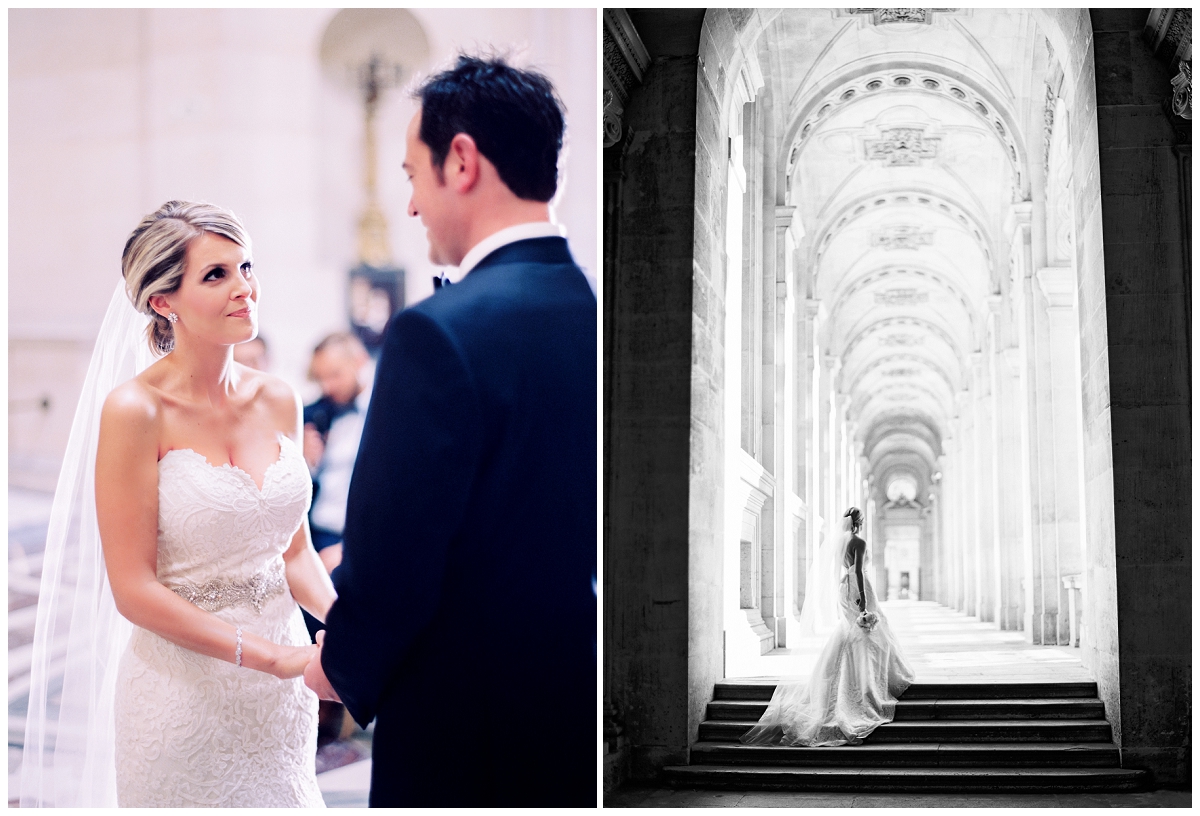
(7, 7), (600, 808)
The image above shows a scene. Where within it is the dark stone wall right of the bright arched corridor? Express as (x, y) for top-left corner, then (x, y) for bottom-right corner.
(1091, 8), (1192, 782)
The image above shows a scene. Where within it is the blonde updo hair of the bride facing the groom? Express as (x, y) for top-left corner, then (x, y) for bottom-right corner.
(121, 202), (250, 354)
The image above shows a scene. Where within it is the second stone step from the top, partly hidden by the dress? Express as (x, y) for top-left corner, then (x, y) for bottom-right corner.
(707, 697), (1104, 721)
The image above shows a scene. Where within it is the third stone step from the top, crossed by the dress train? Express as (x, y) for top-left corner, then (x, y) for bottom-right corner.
(700, 720), (1112, 744)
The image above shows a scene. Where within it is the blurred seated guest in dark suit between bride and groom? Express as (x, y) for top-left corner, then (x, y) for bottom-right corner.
(304, 331), (371, 572)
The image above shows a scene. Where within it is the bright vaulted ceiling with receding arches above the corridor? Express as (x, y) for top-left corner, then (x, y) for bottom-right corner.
(757, 8), (1042, 504)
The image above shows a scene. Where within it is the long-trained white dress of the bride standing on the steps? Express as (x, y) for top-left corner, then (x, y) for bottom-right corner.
(742, 537), (914, 746)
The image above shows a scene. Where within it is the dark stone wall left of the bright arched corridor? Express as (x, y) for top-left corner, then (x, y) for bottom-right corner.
(604, 12), (702, 778)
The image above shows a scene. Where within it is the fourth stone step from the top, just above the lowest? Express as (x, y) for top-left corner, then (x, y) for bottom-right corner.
(690, 743), (1121, 768)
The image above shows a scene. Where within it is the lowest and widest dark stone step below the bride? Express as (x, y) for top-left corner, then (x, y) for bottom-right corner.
(662, 763), (1150, 793)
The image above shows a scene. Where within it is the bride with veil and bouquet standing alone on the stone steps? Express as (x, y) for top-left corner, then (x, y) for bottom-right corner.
(742, 508), (914, 746)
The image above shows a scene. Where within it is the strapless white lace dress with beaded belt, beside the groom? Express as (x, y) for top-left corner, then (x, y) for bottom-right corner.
(115, 434), (324, 808)
